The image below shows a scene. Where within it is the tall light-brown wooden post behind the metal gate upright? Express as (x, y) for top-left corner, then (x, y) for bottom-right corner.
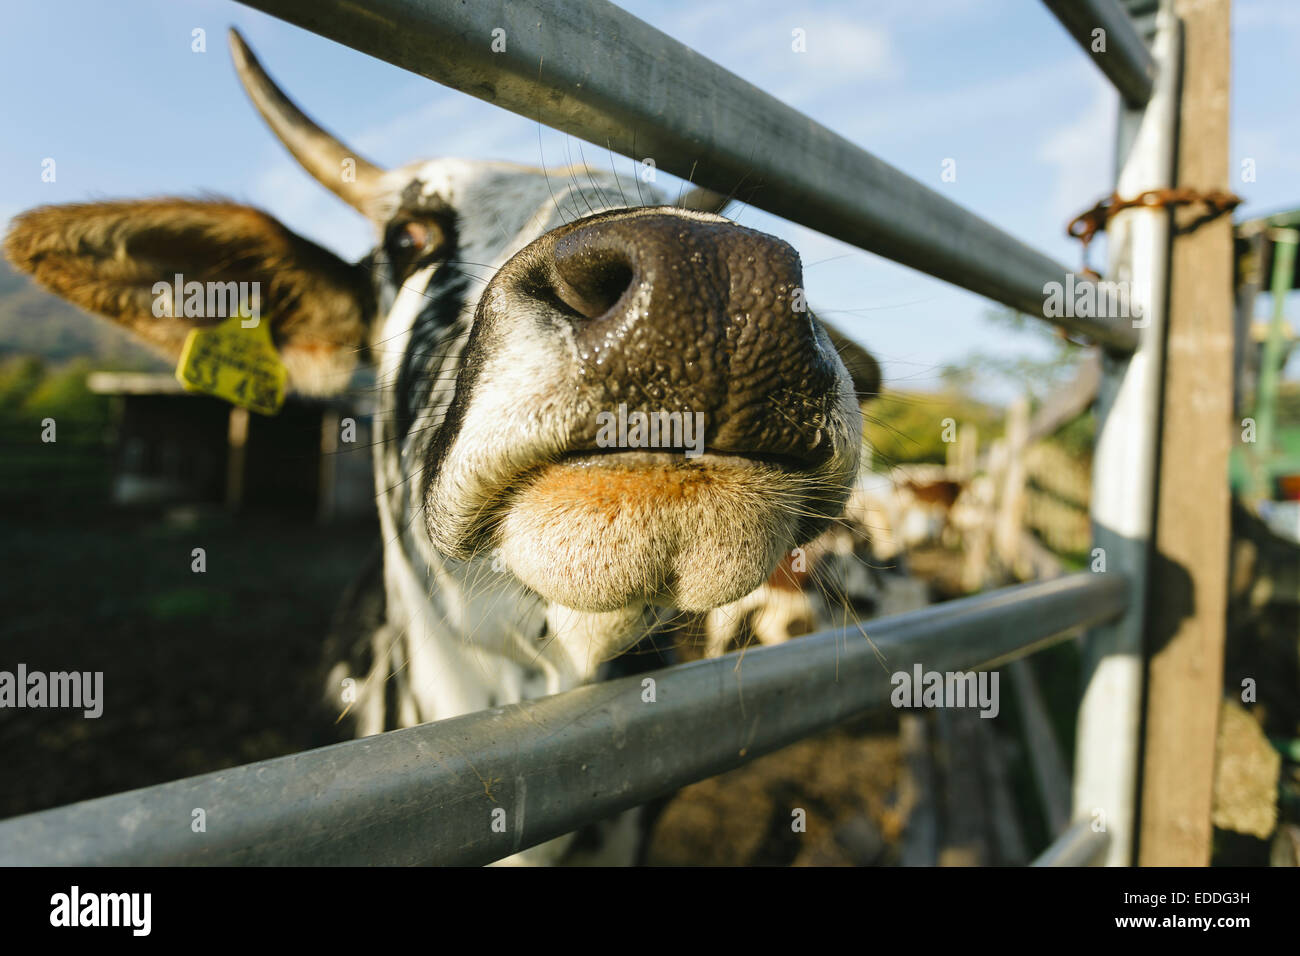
(1138, 0), (1232, 866)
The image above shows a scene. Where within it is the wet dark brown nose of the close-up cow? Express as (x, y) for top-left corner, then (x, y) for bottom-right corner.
(509, 211), (836, 458)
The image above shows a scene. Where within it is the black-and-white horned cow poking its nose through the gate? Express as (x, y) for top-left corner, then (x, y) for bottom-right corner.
(5, 30), (879, 862)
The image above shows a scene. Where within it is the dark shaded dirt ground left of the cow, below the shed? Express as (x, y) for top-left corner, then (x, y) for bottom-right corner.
(0, 496), (366, 817)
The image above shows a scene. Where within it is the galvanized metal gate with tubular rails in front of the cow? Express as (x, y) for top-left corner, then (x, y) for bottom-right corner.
(0, 0), (1230, 864)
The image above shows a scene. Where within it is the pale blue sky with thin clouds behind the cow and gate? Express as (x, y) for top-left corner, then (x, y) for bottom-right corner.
(0, 0), (1300, 400)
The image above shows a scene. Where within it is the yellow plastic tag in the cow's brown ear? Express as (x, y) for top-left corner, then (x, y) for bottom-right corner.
(176, 315), (289, 415)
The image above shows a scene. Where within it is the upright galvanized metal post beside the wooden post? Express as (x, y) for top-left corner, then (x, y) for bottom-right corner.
(1074, 3), (1180, 866)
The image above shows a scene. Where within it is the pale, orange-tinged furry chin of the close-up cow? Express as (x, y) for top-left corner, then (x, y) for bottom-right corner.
(498, 453), (826, 611)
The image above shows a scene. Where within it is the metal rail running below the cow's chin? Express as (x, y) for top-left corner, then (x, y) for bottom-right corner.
(0, 572), (1128, 865)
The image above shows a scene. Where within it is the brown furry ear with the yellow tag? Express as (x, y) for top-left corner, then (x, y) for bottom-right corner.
(4, 199), (372, 394)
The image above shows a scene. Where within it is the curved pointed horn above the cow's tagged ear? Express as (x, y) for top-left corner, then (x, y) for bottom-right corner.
(230, 27), (384, 217)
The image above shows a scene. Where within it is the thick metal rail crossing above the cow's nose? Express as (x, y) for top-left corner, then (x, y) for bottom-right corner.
(233, 0), (1136, 350)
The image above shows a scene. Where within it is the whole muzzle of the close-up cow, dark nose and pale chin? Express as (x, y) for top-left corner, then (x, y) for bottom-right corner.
(425, 208), (862, 611)
